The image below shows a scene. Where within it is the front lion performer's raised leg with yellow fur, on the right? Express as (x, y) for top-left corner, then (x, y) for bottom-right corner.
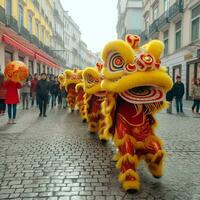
(145, 135), (165, 178)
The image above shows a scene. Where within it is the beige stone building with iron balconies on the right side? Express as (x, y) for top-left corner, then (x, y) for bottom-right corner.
(141, 0), (200, 99)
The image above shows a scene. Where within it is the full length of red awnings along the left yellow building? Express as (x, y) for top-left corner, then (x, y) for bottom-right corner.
(2, 34), (59, 68)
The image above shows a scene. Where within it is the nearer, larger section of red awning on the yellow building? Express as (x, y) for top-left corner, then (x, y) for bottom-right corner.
(2, 34), (35, 57)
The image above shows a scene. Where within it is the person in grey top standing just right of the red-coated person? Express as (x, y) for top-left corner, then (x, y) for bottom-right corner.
(21, 78), (31, 110)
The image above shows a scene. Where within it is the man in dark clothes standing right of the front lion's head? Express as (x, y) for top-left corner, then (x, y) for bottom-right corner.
(172, 75), (185, 114)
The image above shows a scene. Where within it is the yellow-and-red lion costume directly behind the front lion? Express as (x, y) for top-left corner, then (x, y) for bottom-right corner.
(83, 63), (109, 140)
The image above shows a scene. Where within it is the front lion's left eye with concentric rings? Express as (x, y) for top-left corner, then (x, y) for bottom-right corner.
(108, 53), (125, 72)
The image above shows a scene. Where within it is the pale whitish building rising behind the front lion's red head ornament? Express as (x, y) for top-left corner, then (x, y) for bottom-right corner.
(117, 0), (142, 39)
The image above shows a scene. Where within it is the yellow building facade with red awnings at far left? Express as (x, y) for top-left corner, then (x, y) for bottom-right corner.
(0, 0), (60, 74)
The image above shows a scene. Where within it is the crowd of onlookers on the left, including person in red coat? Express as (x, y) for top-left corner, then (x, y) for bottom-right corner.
(0, 73), (67, 124)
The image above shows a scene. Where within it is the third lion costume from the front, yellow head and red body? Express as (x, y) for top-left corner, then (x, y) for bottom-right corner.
(64, 69), (81, 112)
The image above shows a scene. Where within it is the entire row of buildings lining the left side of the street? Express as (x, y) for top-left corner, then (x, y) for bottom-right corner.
(0, 0), (98, 74)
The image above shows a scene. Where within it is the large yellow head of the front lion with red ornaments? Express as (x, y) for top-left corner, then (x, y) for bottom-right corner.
(101, 34), (172, 103)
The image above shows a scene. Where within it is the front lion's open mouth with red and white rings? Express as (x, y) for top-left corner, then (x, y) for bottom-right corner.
(120, 86), (165, 104)
